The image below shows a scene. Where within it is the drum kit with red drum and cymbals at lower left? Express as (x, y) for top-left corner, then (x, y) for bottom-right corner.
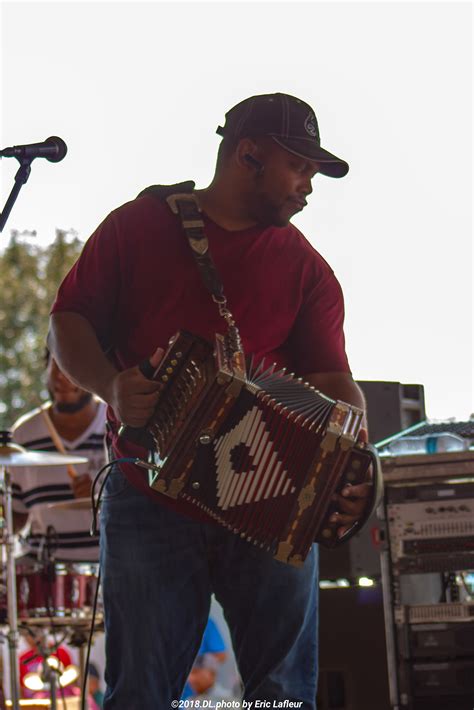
(0, 431), (101, 710)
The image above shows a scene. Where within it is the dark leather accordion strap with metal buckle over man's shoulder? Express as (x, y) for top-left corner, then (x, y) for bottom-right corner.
(138, 180), (235, 328)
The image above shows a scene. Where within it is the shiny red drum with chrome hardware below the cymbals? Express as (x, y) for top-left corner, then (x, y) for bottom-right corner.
(16, 562), (98, 620)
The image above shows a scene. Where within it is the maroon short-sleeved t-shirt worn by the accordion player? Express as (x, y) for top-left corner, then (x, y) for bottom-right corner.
(52, 195), (350, 518)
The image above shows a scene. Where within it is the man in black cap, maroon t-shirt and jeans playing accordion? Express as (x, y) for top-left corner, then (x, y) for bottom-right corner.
(50, 94), (370, 710)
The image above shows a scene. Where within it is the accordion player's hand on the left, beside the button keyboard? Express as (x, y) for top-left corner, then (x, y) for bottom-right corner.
(107, 348), (164, 427)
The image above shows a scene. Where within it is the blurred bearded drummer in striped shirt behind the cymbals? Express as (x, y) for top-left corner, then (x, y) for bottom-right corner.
(13, 354), (106, 562)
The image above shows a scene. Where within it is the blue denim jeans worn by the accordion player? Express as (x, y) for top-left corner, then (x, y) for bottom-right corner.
(100, 466), (318, 710)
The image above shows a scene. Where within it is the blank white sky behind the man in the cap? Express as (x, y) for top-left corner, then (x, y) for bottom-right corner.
(0, 0), (474, 418)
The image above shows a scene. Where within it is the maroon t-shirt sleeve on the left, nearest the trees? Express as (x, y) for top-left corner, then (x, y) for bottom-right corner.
(51, 212), (121, 349)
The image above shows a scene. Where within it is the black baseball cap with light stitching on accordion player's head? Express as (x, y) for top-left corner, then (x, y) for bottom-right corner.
(216, 93), (349, 177)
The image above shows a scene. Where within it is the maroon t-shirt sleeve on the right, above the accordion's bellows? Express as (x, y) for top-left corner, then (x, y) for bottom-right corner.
(290, 262), (351, 375)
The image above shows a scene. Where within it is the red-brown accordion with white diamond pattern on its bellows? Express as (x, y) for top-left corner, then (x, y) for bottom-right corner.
(123, 331), (371, 565)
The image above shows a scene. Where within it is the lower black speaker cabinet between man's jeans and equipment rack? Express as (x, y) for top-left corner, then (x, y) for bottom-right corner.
(317, 585), (390, 710)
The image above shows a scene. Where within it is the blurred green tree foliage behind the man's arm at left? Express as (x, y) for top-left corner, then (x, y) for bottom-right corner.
(0, 229), (83, 429)
